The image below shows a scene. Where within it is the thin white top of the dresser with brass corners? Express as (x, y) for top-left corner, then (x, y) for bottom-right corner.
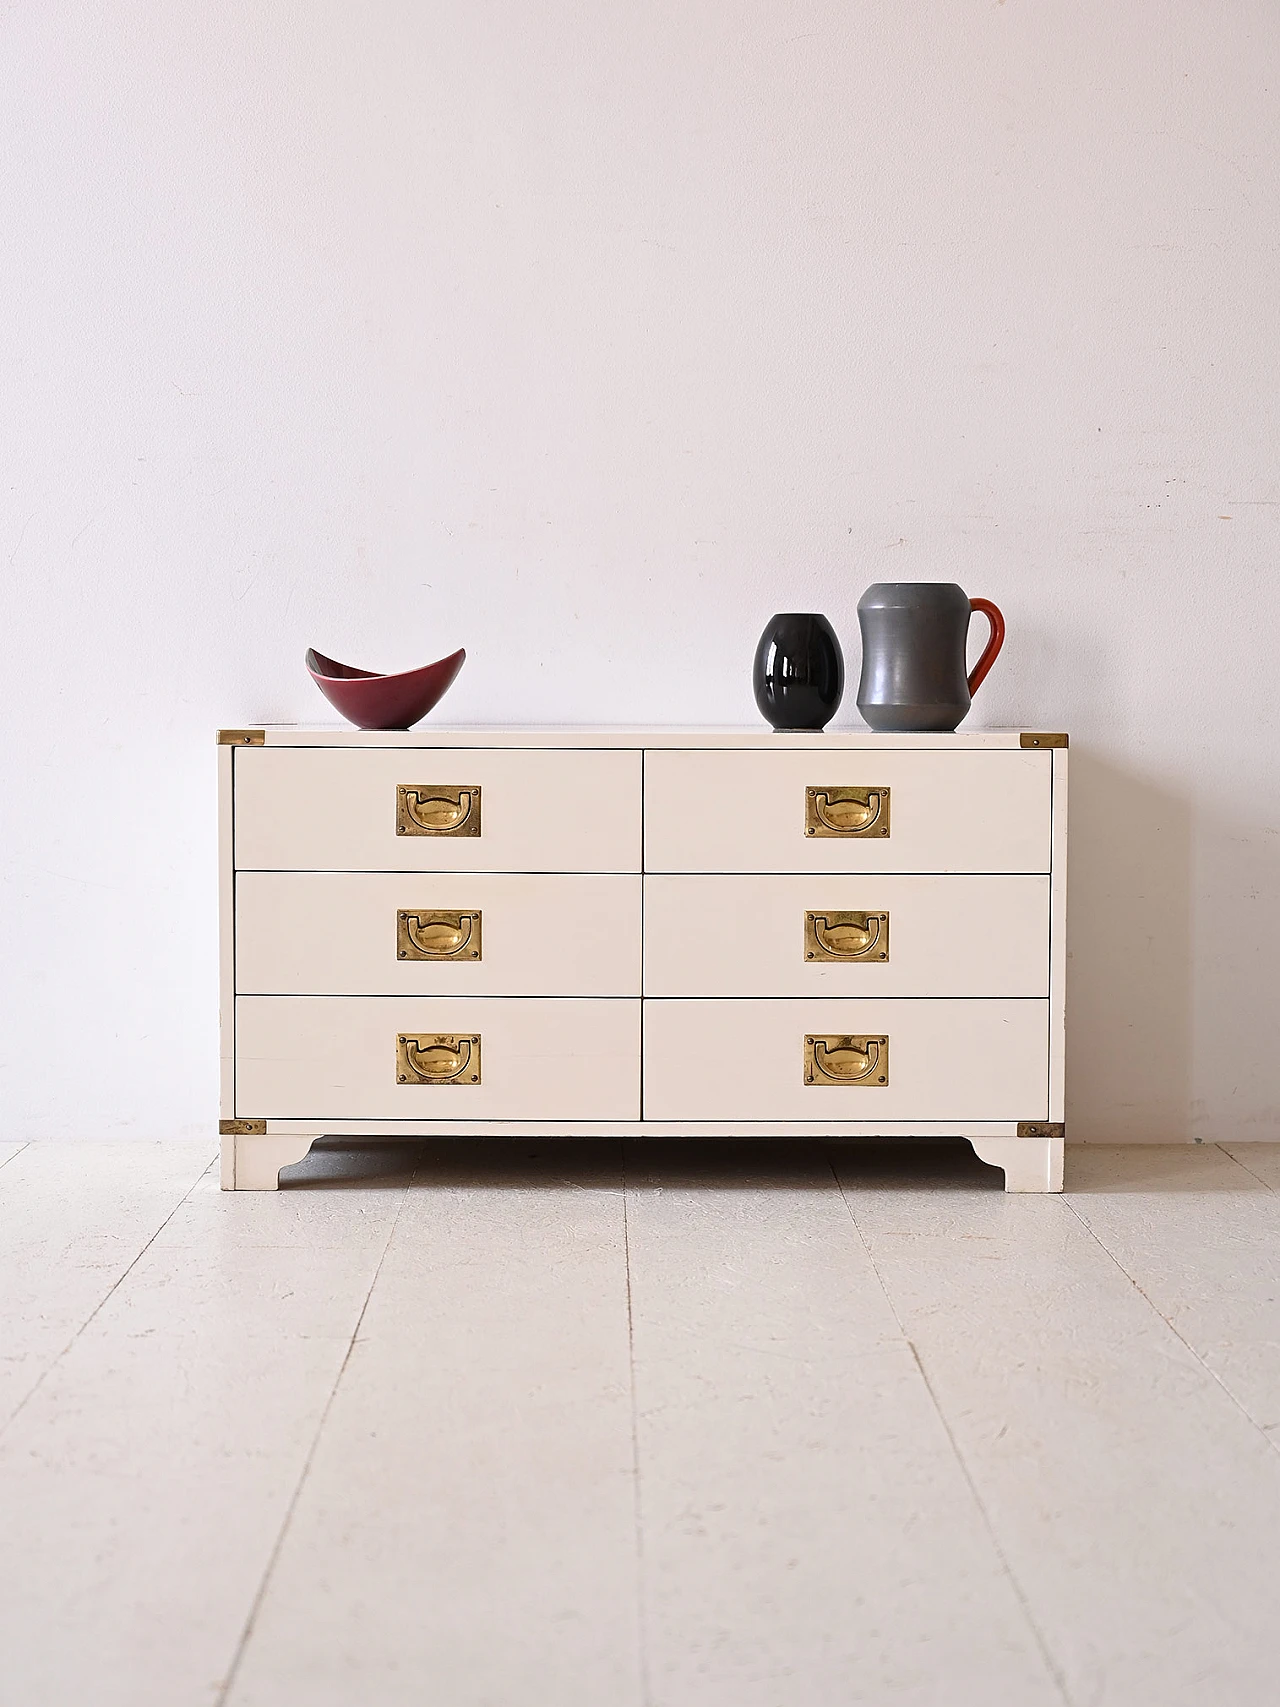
(218, 724), (1067, 753)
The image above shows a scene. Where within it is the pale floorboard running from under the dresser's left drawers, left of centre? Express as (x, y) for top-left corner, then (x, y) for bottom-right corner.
(229, 1140), (642, 1707)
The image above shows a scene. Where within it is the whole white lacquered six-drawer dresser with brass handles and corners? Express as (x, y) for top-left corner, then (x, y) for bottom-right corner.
(218, 727), (1067, 1191)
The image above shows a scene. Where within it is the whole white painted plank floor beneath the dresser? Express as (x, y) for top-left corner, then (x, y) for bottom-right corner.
(0, 1142), (1280, 1707)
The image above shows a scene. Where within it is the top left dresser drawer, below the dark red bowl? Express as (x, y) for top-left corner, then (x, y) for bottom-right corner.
(234, 746), (640, 872)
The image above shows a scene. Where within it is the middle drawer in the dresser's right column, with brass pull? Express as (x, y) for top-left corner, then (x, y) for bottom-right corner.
(645, 874), (1050, 999)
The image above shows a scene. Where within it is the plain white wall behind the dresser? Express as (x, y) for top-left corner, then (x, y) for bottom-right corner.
(0, 0), (1280, 1140)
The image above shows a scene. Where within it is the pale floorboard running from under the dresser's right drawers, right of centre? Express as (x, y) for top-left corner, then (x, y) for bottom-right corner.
(628, 1145), (1062, 1707)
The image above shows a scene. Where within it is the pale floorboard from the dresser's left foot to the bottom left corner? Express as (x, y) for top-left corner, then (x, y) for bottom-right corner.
(0, 1147), (406, 1707)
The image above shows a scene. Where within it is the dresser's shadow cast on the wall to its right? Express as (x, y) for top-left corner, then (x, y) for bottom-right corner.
(1067, 746), (1201, 1144)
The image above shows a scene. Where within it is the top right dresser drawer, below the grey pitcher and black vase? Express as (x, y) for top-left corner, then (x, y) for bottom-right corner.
(645, 748), (1051, 872)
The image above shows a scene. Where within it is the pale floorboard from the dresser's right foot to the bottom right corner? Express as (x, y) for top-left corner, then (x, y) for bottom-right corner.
(838, 1149), (1280, 1707)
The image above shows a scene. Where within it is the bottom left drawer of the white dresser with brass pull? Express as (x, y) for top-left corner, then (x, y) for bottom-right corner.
(236, 995), (640, 1125)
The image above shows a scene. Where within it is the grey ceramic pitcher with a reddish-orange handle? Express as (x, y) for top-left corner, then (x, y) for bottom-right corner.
(858, 580), (1005, 731)
